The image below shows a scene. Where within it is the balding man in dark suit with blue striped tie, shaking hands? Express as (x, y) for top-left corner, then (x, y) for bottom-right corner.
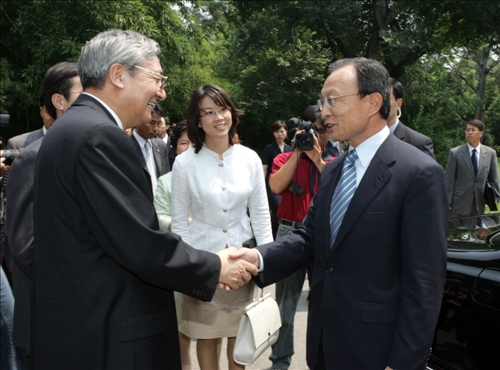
(232, 58), (448, 370)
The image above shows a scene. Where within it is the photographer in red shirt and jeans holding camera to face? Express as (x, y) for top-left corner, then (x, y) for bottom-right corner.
(269, 105), (334, 369)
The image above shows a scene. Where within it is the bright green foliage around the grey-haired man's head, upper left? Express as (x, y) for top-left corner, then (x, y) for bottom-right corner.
(0, 0), (225, 137)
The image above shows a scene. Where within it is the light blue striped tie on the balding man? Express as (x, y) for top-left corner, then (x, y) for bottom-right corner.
(330, 149), (358, 249)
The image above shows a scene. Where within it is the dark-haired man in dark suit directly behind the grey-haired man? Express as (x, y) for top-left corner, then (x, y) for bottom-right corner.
(6, 62), (82, 369)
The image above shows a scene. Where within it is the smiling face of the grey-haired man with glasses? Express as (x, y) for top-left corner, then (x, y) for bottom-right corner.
(120, 57), (166, 127)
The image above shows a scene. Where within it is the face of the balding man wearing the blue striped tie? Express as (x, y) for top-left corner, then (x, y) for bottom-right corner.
(321, 65), (372, 147)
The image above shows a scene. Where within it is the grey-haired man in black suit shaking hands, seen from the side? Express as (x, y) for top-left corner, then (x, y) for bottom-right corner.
(32, 30), (256, 369)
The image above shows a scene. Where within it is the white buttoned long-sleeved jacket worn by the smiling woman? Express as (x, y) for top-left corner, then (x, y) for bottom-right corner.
(172, 145), (273, 253)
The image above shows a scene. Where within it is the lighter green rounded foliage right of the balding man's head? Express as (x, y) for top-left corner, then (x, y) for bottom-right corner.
(401, 54), (500, 167)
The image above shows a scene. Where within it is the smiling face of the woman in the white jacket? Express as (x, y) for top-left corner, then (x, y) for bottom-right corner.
(198, 96), (233, 146)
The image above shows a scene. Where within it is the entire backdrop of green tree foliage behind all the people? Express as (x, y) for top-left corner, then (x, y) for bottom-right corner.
(0, 0), (500, 161)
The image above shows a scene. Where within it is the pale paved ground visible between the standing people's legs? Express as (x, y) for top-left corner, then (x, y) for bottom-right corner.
(191, 280), (309, 370)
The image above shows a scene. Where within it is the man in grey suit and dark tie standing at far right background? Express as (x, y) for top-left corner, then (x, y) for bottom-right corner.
(446, 119), (500, 218)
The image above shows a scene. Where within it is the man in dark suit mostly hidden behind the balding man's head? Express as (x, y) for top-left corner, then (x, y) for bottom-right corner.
(387, 77), (434, 158)
